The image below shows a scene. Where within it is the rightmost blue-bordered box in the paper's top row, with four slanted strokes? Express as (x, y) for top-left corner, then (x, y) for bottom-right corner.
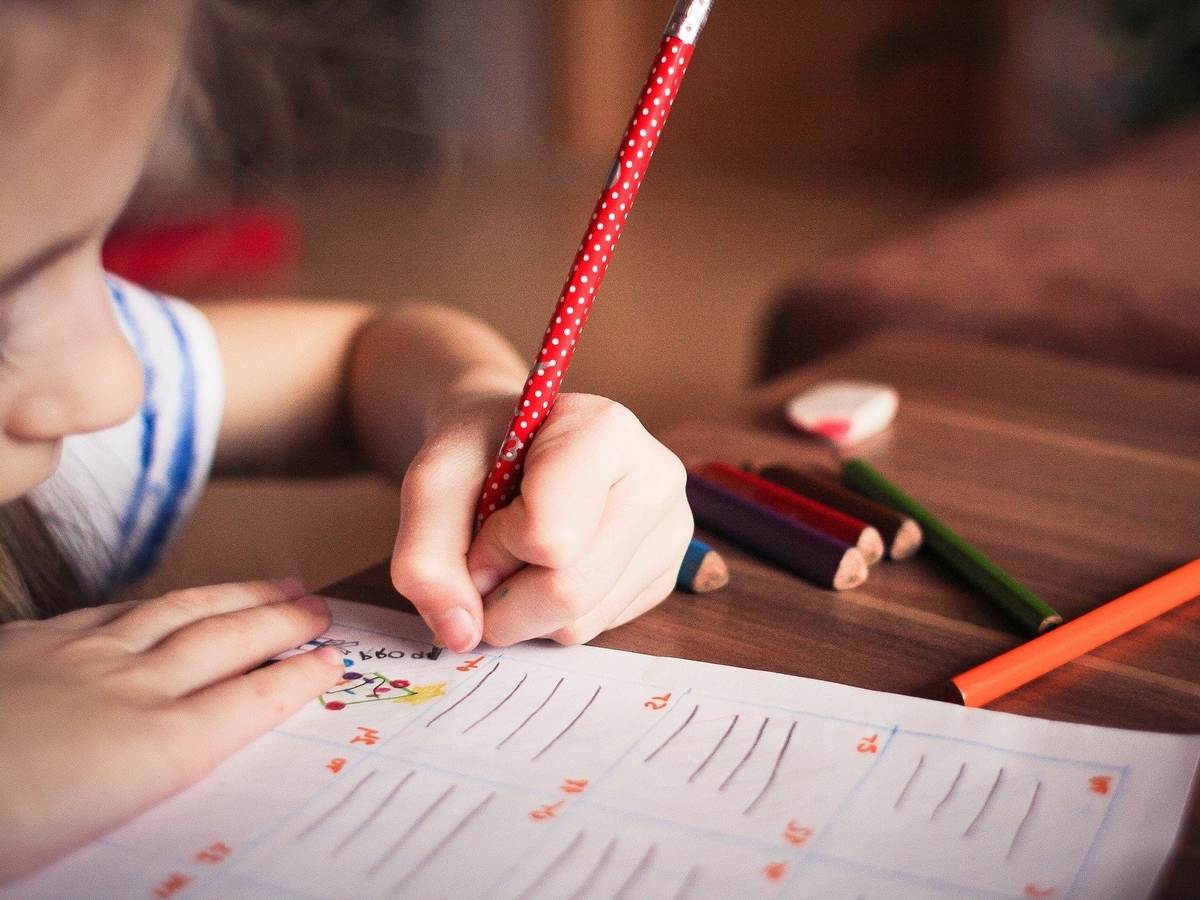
(806, 732), (1123, 898)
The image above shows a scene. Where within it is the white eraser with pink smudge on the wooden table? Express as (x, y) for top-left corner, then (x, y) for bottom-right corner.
(787, 382), (900, 446)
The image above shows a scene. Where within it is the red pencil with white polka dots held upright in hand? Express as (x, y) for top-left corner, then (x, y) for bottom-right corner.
(475, 0), (713, 529)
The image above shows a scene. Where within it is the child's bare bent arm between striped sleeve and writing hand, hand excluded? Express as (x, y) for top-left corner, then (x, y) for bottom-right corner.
(204, 300), (526, 479)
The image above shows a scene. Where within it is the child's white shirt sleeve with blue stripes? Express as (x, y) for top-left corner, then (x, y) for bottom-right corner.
(31, 276), (224, 595)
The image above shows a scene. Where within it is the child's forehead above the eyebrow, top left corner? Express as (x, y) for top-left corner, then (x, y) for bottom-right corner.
(0, 0), (186, 263)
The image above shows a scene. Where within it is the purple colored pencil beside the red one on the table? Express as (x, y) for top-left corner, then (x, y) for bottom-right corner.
(688, 472), (868, 590)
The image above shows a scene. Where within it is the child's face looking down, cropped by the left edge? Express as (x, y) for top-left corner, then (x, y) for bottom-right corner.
(0, 0), (187, 502)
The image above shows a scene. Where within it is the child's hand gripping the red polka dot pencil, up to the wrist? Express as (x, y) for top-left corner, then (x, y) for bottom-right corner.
(391, 394), (692, 652)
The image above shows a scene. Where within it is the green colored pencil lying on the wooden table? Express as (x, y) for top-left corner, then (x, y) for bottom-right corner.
(841, 460), (1062, 635)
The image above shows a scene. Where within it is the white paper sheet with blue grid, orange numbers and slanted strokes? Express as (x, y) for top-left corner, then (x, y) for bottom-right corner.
(7, 601), (1200, 900)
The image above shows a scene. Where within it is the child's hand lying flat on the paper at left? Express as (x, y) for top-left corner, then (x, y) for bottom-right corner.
(0, 581), (342, 883)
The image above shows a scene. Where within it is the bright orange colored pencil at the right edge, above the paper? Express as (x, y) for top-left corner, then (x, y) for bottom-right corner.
(950, 559), (1200, 707)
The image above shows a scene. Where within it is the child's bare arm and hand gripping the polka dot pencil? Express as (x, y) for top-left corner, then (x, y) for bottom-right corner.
(205, 304), (691, 650)
